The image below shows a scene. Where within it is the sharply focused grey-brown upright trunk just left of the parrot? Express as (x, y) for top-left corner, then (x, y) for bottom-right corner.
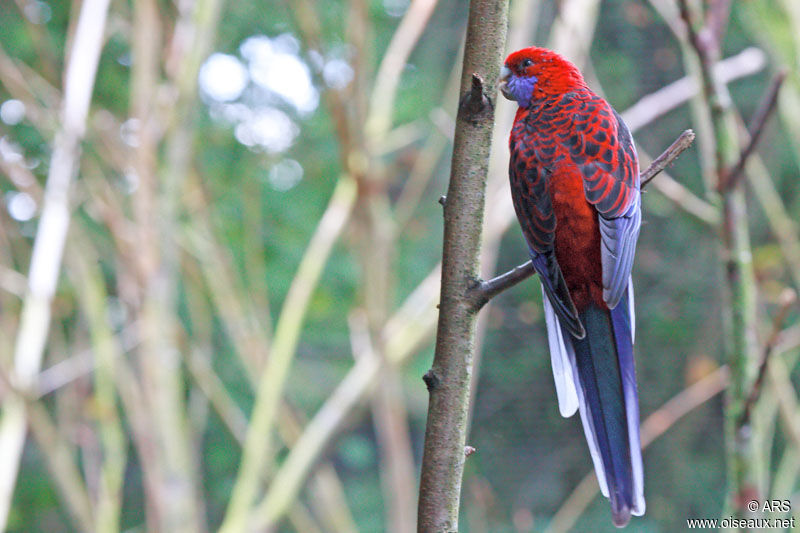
(417, 0), (508, 532)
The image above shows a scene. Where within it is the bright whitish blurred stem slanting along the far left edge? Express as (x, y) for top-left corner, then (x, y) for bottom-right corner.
(0, 0), (109, 529)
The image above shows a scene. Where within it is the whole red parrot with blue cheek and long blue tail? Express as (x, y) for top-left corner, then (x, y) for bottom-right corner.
(498, 47), (645, 527)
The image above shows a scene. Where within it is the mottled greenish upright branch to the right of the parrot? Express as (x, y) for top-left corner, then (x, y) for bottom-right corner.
(680, 0), (764, 517)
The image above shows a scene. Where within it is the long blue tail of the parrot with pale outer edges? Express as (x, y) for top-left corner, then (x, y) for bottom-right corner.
(545, 280), (645, 527)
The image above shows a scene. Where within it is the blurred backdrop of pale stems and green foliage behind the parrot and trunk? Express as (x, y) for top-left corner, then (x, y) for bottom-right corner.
(0, 0), (800, 533)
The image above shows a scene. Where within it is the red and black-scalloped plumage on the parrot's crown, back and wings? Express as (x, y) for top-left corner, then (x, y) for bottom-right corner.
(506, 48), (638, 311)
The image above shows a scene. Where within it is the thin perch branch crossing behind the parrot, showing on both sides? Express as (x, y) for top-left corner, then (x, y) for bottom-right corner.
(470, 130), (694, 309)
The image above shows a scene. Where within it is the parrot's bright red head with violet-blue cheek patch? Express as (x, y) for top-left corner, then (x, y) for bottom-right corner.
(500, 46), (586, 107)
